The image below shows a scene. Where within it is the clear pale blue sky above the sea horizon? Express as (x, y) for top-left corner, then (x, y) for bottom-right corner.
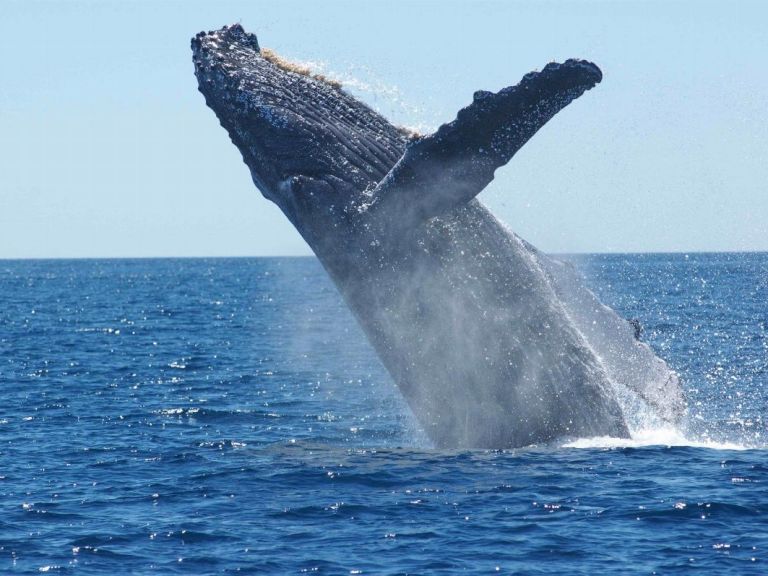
(0, 0), (768, 258)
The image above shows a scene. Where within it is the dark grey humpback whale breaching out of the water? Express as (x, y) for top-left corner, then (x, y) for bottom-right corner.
(192, 25), (685, 448)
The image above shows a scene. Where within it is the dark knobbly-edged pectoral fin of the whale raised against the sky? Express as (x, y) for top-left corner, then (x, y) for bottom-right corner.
(371, 60), (602, 226)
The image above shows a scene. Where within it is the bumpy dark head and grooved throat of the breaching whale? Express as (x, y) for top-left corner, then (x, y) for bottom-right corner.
(192, 24), (406, 227)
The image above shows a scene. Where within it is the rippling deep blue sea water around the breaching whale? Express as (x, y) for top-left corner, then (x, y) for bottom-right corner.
(0, 254), (768, 575)
